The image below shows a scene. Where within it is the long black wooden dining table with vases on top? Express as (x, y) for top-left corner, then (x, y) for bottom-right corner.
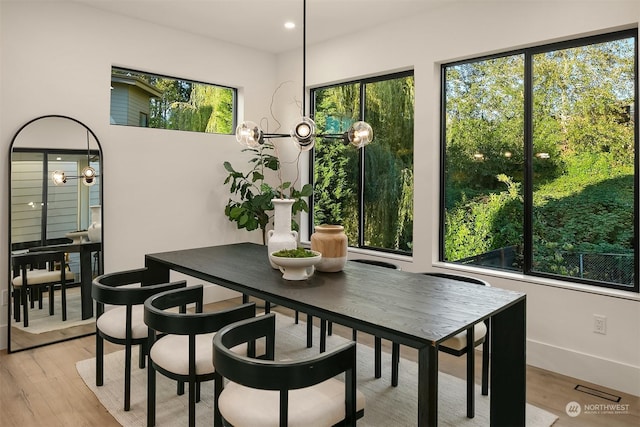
(145, 243), (526, 426)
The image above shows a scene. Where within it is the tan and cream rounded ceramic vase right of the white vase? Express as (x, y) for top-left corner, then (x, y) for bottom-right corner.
(311, 224), (348, 273)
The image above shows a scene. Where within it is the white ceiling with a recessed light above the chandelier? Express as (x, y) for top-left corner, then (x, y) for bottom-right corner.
(70, 0), (450, 53)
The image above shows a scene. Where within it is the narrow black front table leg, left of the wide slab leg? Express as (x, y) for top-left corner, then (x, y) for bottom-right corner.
(418, 345), (438, 427)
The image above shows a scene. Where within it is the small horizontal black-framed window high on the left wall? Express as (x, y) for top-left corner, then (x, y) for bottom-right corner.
(110, 67), (236, 134)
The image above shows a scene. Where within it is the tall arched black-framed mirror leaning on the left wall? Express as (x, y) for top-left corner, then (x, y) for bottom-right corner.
(8, 115), (104, 352)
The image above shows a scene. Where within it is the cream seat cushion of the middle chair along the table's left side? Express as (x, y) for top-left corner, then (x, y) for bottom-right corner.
(150, 332), (247, 375)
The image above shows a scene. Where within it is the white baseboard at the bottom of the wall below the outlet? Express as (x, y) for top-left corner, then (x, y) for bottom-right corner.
(527, 340), (640, 396)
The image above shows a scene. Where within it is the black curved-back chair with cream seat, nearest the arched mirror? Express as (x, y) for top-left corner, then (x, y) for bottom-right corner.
(91, 268), (187, 411)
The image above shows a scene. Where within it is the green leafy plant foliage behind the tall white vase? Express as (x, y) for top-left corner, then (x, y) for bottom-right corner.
(224, 141), (313, 244)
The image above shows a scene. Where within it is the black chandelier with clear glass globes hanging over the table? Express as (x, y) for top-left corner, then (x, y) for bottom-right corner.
(236, 0), (373, 151)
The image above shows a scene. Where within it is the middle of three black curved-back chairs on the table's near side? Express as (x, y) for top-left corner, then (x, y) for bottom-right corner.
(144, 285), (256, 426)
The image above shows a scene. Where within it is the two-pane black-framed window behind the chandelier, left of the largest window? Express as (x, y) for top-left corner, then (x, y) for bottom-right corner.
(312, 72), (414, 254)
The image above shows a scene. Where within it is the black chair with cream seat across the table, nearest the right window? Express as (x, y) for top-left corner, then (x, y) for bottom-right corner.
(391, 272), (491, 418)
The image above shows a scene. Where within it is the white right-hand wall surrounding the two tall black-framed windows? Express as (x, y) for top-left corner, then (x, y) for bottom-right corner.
(278, 0), (640, 395)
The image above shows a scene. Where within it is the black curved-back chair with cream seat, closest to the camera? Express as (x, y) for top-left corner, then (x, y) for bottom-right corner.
(213, 314), (365, 427)
